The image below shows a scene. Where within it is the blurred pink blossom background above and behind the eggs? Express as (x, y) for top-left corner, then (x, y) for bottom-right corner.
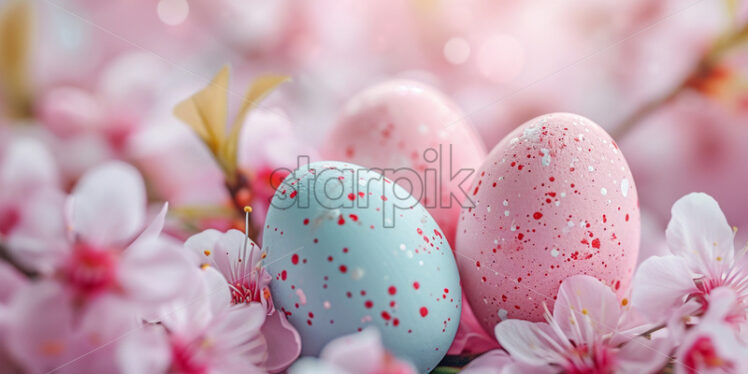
(0, 0), (748, 257)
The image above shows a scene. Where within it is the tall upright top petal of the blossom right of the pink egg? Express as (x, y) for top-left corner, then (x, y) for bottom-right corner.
(665, 193), (735, 275)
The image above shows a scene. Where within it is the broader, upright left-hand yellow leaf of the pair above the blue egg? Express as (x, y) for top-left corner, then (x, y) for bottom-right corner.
(174, 66), (229, 155)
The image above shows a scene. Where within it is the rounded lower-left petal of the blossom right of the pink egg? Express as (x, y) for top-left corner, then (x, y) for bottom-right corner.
(631, 256), (698, 322)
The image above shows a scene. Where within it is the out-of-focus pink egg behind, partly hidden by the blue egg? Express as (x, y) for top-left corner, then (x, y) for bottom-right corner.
(322, 80), (486, 243)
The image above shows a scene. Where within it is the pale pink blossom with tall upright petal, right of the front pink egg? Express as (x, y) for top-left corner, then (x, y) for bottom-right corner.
(631, 193), (748, 326)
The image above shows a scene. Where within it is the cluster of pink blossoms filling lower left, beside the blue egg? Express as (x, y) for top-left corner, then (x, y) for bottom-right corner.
(0, 140), (300, 373)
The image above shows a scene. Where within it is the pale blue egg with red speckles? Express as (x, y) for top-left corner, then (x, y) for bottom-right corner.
(263, 161), (461, 372)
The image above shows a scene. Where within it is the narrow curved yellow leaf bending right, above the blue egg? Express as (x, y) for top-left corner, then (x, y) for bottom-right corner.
(219, 74), (290, 180)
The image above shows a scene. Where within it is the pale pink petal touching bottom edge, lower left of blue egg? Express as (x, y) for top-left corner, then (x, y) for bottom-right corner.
(116, 325), (171, 374)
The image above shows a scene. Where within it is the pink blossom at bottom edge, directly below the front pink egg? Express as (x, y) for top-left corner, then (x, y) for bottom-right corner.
(465, 275), (670, 373)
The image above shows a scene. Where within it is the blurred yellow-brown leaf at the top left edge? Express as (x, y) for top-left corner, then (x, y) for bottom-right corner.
(0, 0), (32, 117)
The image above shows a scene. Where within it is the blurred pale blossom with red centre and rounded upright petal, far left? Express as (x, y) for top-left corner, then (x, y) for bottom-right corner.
(9, 162), (190, 306)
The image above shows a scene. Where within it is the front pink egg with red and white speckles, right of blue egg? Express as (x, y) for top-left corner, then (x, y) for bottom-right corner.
(456, 113), (640, 331)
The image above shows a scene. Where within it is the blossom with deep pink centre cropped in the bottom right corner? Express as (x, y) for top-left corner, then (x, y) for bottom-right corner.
(675, 287), (748, 374)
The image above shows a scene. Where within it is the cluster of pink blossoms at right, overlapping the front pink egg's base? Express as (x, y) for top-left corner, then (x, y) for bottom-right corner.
(464, 193), (748, 374)
